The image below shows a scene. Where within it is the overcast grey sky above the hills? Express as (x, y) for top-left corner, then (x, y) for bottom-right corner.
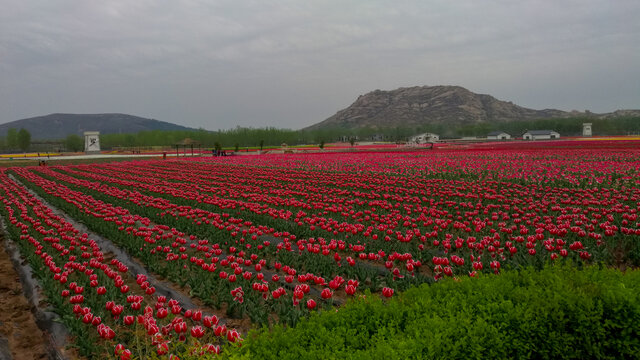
(0, 0), (640, 130)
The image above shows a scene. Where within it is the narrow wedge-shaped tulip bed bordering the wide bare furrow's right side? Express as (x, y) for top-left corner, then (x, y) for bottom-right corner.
(16, 169), (390, 330)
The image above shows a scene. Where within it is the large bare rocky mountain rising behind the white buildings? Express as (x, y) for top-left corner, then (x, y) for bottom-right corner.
(305, 86), (640, 130)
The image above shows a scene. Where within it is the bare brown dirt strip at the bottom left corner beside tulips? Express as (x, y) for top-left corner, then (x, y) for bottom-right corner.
(0, 232), (48, 359)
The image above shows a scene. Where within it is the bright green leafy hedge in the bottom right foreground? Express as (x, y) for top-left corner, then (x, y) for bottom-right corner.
(224, 265), (640, 360)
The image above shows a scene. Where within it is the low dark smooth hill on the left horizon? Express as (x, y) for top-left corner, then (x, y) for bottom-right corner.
(0, 114), (194, 140)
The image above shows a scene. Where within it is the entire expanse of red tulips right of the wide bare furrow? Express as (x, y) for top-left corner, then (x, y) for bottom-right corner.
(6, 141), (640, 358)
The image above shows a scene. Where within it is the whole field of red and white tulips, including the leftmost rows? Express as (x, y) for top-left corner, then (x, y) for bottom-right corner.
(0, 141), (640, 359)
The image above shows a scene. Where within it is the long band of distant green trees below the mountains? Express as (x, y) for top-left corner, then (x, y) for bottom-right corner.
(30, 117), (640, 150)
